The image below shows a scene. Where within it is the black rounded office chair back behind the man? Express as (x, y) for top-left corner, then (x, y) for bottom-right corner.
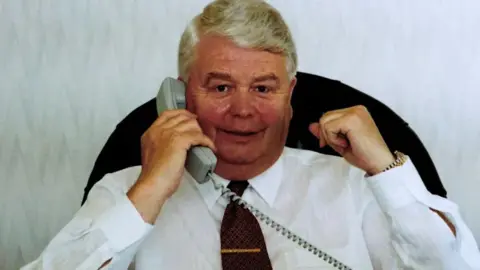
(82, 72), (447, 204)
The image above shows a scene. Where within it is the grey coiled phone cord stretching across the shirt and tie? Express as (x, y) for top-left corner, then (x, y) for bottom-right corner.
(210, 175), (352, 270)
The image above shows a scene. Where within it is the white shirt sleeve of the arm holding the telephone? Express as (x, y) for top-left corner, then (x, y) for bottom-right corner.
(21, 168), (152, 270)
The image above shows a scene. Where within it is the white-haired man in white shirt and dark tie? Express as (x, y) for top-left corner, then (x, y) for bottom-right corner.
(24, 0), (480, 270)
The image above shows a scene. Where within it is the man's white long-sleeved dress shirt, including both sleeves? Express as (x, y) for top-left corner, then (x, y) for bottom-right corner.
(23, 148), (480, 270)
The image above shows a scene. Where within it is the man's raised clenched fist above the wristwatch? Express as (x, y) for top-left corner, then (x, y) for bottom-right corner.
(309, 106), (395, 175)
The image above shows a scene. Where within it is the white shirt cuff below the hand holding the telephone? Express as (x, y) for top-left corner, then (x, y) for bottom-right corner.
(94, 195), (153, 253)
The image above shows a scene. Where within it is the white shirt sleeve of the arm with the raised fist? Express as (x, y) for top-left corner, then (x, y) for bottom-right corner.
(362, 159), (480, 270)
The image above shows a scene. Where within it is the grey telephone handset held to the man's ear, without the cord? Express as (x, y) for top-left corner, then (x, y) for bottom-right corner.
(156, 78), (217, 184)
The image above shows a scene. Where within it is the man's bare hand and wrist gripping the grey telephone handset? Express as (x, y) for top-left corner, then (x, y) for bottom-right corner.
(127, 107), (215, 224)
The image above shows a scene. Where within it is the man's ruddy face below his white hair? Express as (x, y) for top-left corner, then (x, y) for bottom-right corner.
(186, 36), (295, 174)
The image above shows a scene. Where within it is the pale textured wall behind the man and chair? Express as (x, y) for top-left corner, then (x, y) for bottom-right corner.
(0, 0), (480, 269)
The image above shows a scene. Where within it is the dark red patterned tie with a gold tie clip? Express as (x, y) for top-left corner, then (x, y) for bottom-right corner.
(220, 181), (272, 270)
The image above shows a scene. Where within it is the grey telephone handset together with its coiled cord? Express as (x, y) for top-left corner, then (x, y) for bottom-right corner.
(156, 78), (351, 270)
